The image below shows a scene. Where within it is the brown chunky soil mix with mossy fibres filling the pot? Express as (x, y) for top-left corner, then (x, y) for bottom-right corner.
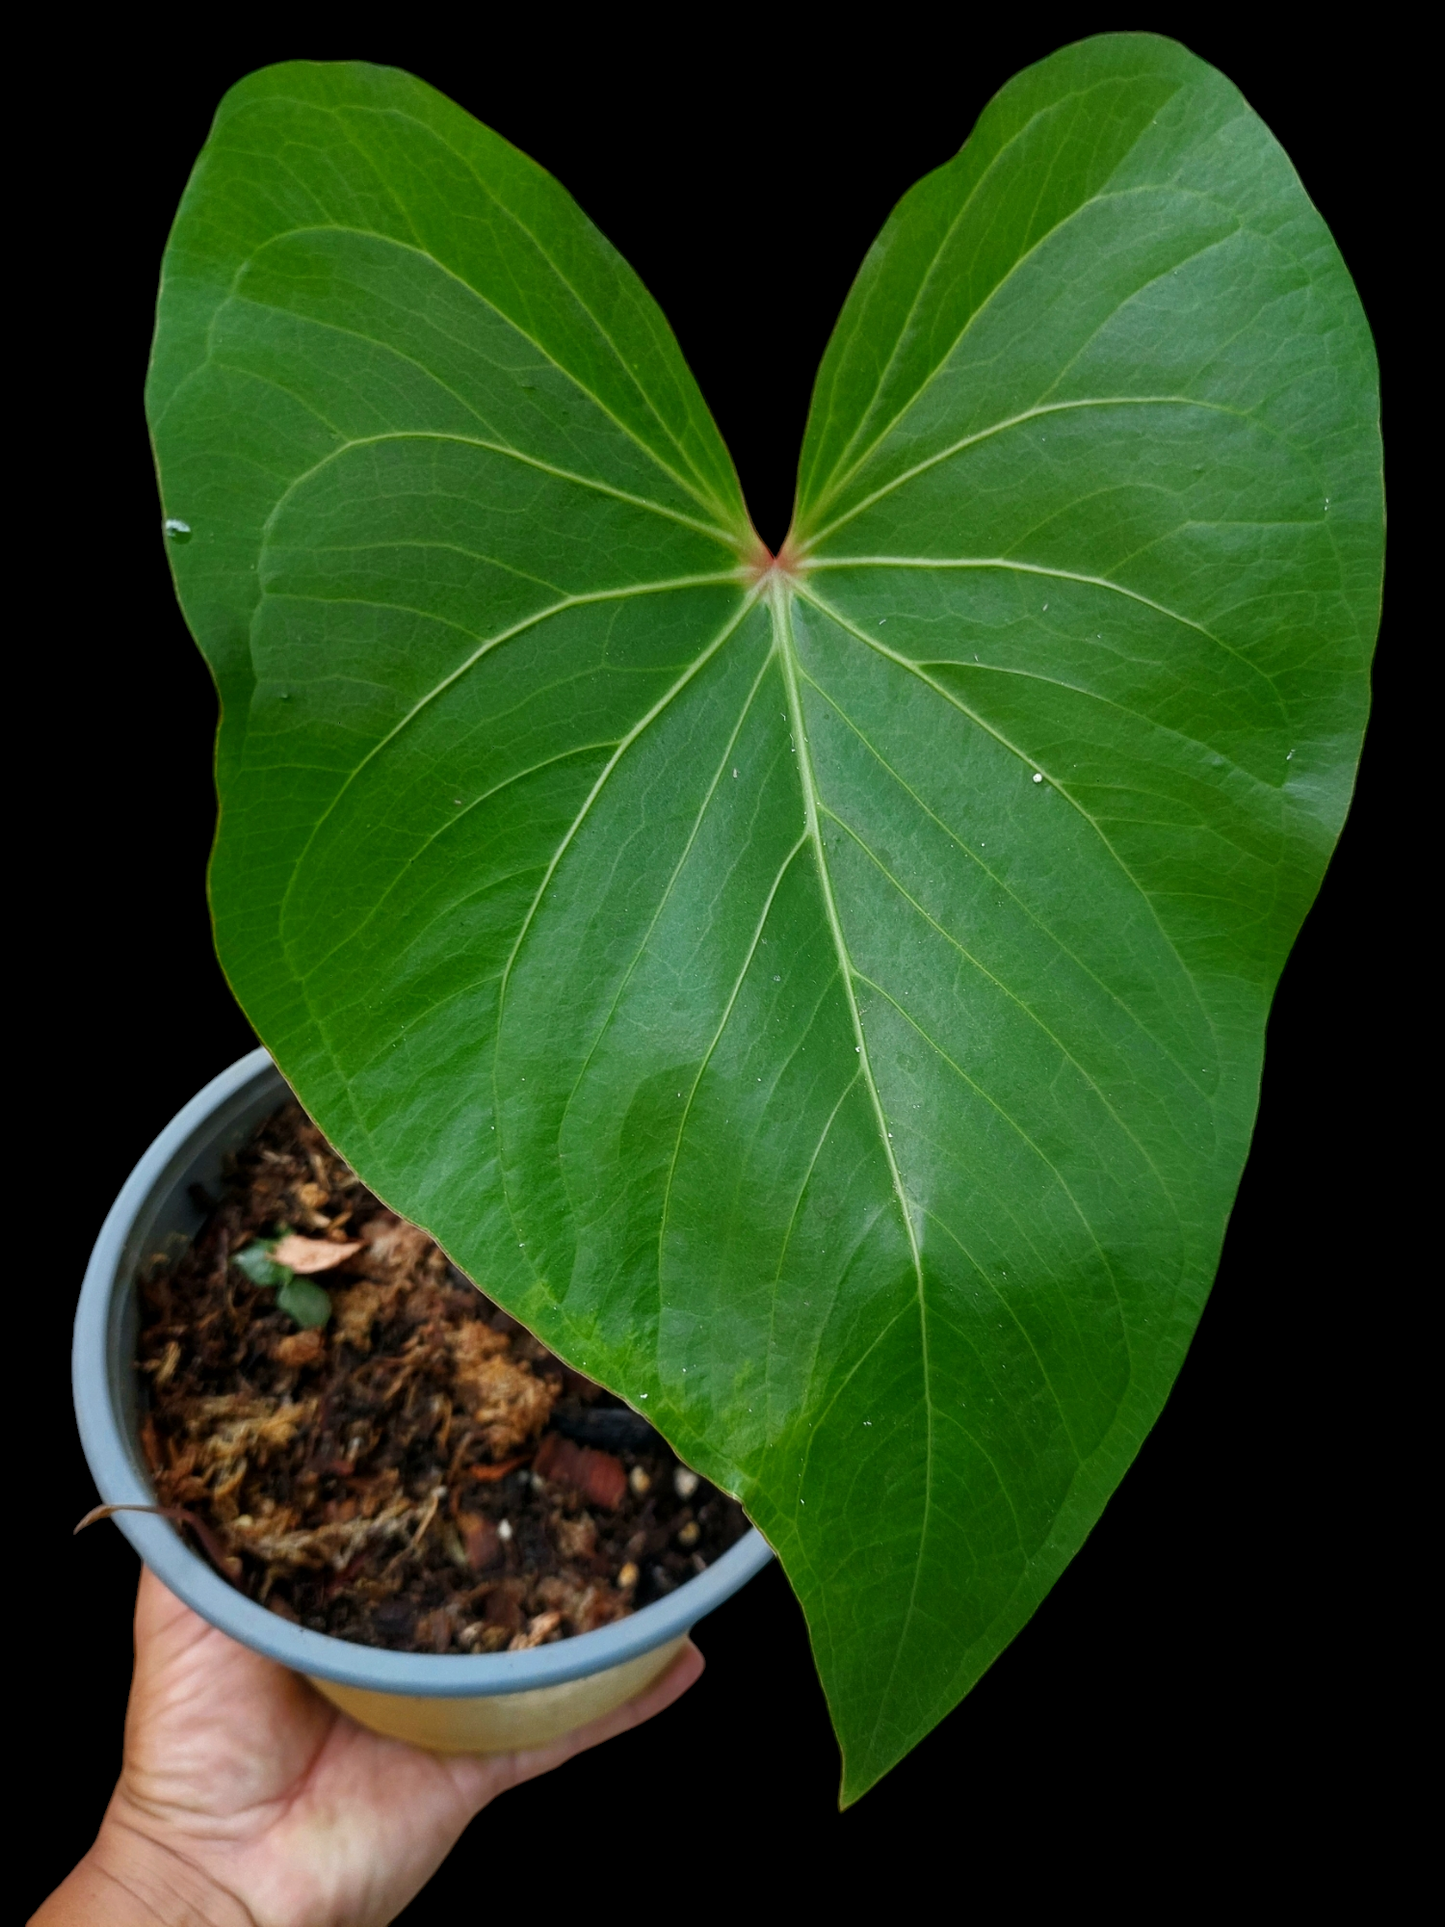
(139, 1104), (748, 1653)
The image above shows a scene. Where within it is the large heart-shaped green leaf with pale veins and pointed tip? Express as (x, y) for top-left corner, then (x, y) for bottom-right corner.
(150, 35), (1381, 1798)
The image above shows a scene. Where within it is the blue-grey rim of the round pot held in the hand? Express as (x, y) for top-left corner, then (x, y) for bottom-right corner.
(71, 1048), (773, 1700)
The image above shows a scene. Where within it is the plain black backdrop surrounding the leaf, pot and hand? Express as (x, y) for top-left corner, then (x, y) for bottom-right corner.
(22, 6), (1420, 1923)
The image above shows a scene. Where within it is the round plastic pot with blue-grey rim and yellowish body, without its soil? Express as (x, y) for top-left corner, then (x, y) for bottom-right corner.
(71, 1050), (773, 1754)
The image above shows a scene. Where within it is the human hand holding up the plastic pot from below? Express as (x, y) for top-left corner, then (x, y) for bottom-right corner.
(35, 1571), (703, 1927)
